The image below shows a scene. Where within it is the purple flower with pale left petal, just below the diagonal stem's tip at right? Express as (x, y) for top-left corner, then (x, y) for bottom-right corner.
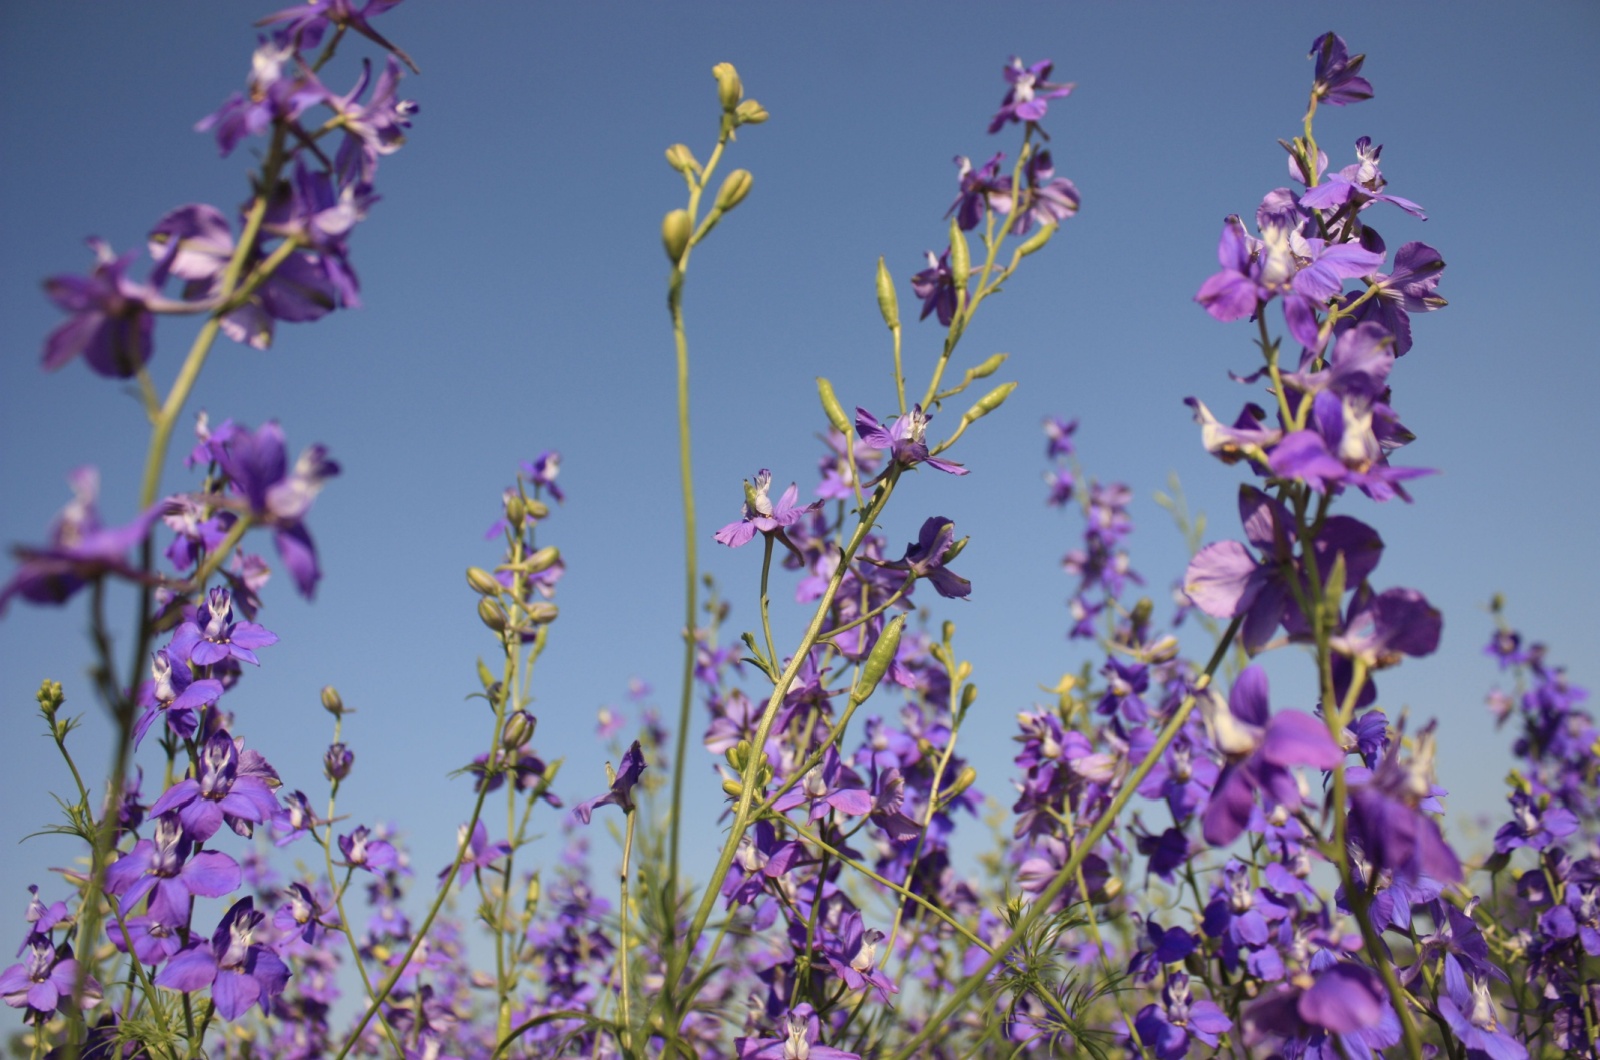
(1202, 666), (1344, 847)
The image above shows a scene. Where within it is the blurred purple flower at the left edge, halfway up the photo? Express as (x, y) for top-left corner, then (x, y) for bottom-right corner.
(0, 468), (166, 615)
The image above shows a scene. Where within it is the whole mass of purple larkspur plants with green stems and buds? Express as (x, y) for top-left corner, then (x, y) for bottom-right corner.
(0, 14), (1600, 1060)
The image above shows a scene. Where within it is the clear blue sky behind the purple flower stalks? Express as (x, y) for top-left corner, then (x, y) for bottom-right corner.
(0, 2), (1600, 941)
